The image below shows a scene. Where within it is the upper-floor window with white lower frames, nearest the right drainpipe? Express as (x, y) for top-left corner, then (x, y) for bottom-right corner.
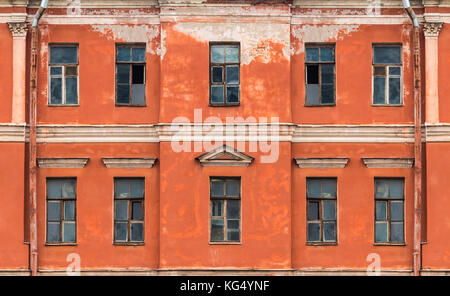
(373, 45), (402, 105)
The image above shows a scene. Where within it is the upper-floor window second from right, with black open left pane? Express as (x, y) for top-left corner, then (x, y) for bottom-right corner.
(305, 45), (335, 106)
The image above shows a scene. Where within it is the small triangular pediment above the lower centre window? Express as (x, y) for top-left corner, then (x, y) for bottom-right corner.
(195, 145), (254, 166)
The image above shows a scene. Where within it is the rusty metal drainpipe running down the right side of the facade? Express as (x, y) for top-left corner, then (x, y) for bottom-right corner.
(403, 0), (422, 276)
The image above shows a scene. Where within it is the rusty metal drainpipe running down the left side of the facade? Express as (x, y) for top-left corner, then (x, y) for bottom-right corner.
(29, 0), (48, 276)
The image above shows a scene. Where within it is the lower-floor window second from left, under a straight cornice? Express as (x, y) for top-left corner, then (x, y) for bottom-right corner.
(114, 178), (144, 243)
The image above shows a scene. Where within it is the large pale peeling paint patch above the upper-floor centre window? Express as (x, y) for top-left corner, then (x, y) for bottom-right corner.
(174, 23), (290, 65)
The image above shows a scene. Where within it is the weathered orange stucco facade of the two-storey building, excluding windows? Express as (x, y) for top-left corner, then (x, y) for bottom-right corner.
(0, 0), (450, 275)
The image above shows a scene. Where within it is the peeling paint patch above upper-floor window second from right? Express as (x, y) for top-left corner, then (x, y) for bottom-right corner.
(291, 25), (359, 55)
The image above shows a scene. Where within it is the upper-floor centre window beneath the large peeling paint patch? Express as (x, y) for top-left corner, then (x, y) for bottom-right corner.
(210, 43), (240, 106)
